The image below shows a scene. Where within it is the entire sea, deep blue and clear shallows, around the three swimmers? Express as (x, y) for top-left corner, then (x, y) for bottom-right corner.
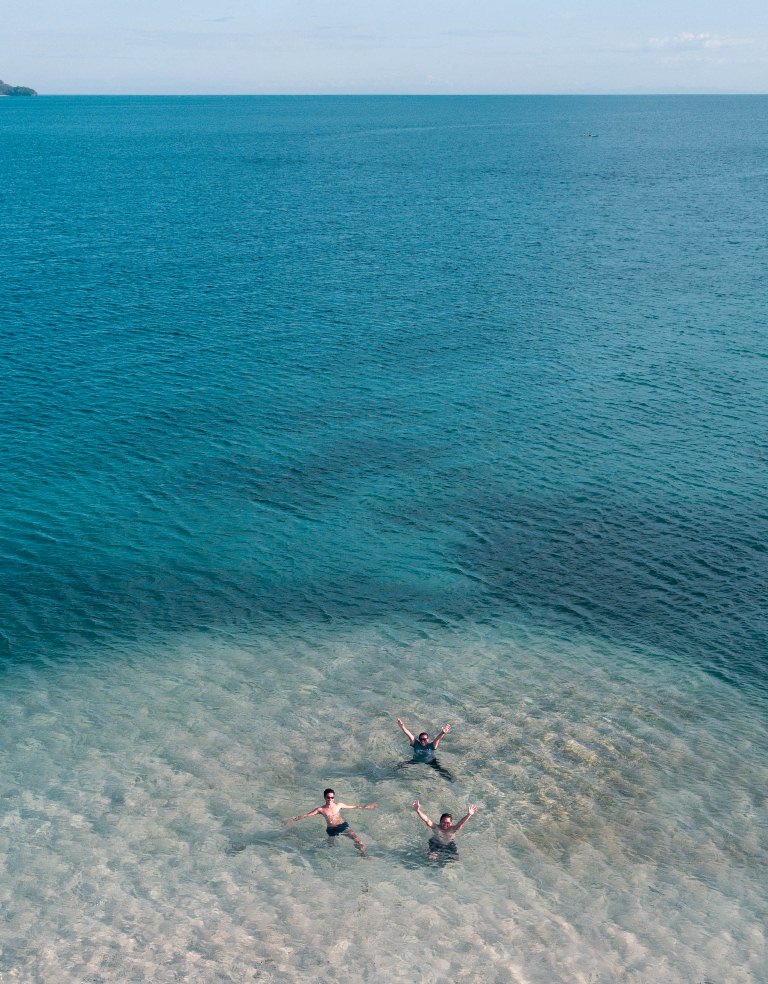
(0, 97), (768, 984)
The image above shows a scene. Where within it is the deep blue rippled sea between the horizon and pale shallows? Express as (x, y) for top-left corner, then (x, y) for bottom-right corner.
(0, 97), (768, 691)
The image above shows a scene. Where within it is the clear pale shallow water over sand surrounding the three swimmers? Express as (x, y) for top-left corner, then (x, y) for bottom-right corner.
(0, 622), (768, 984)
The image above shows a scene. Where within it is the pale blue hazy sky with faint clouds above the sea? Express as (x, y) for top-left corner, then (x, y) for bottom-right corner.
(0, 0), (768, 95)
